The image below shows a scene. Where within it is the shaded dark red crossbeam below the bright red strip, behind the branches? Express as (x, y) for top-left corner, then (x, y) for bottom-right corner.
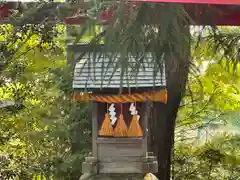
(65, 4), (240, 26)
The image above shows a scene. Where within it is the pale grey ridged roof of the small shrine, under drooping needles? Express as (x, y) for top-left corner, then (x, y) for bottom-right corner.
(73, 53), (166, 89)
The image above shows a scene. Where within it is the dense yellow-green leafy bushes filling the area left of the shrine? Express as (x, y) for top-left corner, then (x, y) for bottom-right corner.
(0, 24), (91, 180)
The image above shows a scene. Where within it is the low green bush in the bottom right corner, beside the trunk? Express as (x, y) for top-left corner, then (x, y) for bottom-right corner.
(173, 135), (240, 180)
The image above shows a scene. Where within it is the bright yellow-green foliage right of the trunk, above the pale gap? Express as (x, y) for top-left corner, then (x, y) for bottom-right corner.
(177, 31), (240, 139)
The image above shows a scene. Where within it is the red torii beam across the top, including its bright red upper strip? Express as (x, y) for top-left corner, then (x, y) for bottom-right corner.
(65, 0), (240, 26)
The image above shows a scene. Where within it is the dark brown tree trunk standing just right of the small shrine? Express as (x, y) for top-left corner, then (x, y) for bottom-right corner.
(152, 27), (190, 180)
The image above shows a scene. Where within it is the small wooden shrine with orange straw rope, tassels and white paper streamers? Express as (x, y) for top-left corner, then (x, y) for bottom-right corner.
(69, 44), (167, 174)
